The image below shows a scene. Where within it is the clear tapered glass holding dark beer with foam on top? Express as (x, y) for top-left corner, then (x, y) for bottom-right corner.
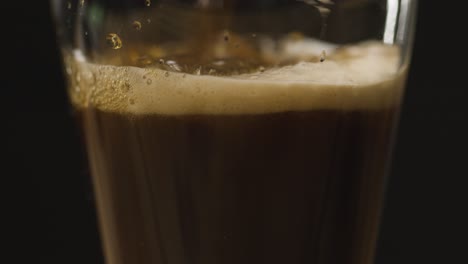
(51, 0), (416, 264)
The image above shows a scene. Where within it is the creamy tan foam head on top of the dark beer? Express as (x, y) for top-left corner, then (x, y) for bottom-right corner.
(70, 42), (406, 115)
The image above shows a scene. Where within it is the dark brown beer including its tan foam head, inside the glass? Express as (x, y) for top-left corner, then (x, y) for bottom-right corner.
(71, 43), (404, 264)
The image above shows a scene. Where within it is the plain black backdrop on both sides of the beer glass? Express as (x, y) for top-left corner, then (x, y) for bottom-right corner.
(1, 0), (468, 264)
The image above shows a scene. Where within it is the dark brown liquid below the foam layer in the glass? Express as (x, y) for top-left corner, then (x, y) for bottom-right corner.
(79, 108), (397, 264)
